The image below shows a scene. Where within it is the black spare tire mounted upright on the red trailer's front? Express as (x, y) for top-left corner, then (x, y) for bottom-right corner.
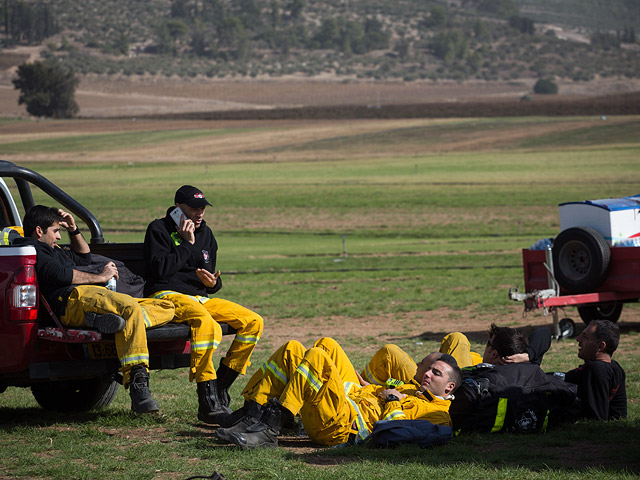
(553, 227), (611, 293)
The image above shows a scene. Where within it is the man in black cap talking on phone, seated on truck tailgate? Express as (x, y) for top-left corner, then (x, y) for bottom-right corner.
(144, 185), (263, 423)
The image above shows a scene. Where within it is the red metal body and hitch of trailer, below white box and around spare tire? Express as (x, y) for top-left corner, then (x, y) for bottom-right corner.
(509, 247), (640, 338)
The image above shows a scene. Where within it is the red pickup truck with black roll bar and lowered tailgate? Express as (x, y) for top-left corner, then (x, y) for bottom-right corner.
(0, 161), (235, 411)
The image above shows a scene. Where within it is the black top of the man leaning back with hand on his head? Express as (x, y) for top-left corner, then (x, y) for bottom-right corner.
(13, 237), (91, 315)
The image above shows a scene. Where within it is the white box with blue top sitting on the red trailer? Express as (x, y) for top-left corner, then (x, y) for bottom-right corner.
(559, 195), (640, 245)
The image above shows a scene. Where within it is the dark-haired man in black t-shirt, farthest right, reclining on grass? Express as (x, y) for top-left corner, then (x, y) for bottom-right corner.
(565, 320), (627, 420)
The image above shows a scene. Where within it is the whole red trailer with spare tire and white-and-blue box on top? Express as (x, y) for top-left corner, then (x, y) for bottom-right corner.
(509, 195), (640, 339)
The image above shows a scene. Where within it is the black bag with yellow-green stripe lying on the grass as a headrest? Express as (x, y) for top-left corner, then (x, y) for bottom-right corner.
(449, 363), (580, 433)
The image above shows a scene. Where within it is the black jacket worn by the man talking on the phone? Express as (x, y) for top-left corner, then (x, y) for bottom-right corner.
(144, 207), (222, 296)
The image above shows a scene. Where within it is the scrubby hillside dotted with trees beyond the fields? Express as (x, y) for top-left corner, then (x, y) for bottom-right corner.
(3, 0), (640, 82)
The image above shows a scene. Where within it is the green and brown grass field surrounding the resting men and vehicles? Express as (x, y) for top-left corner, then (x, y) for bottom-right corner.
(0, 117), (640, 479)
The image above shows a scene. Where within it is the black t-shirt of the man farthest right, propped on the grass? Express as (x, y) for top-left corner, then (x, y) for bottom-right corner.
(565, 360), (627, 420)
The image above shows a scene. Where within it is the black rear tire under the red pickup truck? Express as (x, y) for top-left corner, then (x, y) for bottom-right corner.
(31, 377), (118, 412)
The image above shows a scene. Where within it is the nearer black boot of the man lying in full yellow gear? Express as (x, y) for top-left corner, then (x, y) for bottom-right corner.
(229, 398), (293, 449)
